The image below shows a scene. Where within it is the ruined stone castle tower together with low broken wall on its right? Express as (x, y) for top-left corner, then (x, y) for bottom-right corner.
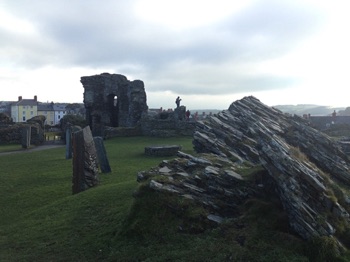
(80, 73), (195, 138)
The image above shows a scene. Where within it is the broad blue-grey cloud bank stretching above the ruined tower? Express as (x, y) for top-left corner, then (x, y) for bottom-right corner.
(2, 0), (326, 94)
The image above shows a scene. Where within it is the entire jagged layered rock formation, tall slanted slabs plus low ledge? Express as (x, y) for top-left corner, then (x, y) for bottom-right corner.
(139, 97), (350, 244)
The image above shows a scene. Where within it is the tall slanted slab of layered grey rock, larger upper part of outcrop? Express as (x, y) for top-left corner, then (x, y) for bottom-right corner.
(193, 97), (350, 238)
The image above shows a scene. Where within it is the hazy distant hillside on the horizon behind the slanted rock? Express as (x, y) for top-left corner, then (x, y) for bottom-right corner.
(273, 104), (345, 116)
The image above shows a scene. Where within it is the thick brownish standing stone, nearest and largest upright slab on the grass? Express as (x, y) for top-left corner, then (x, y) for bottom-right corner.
(72, 126), (98, 194)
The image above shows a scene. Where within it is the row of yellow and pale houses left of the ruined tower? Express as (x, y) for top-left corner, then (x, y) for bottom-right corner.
(2, 96), (84, 126)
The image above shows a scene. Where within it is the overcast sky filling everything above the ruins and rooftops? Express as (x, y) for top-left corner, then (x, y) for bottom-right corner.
(0, 0), (350, 109)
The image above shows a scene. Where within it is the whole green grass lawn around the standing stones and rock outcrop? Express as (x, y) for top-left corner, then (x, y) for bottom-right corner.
(0, 137), (346, 262)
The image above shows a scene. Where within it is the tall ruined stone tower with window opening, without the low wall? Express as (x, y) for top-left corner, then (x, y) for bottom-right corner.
(80, 73), (148, 136)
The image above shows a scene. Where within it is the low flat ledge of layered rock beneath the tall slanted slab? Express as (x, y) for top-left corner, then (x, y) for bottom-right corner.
(137, 151), (262, 220)
